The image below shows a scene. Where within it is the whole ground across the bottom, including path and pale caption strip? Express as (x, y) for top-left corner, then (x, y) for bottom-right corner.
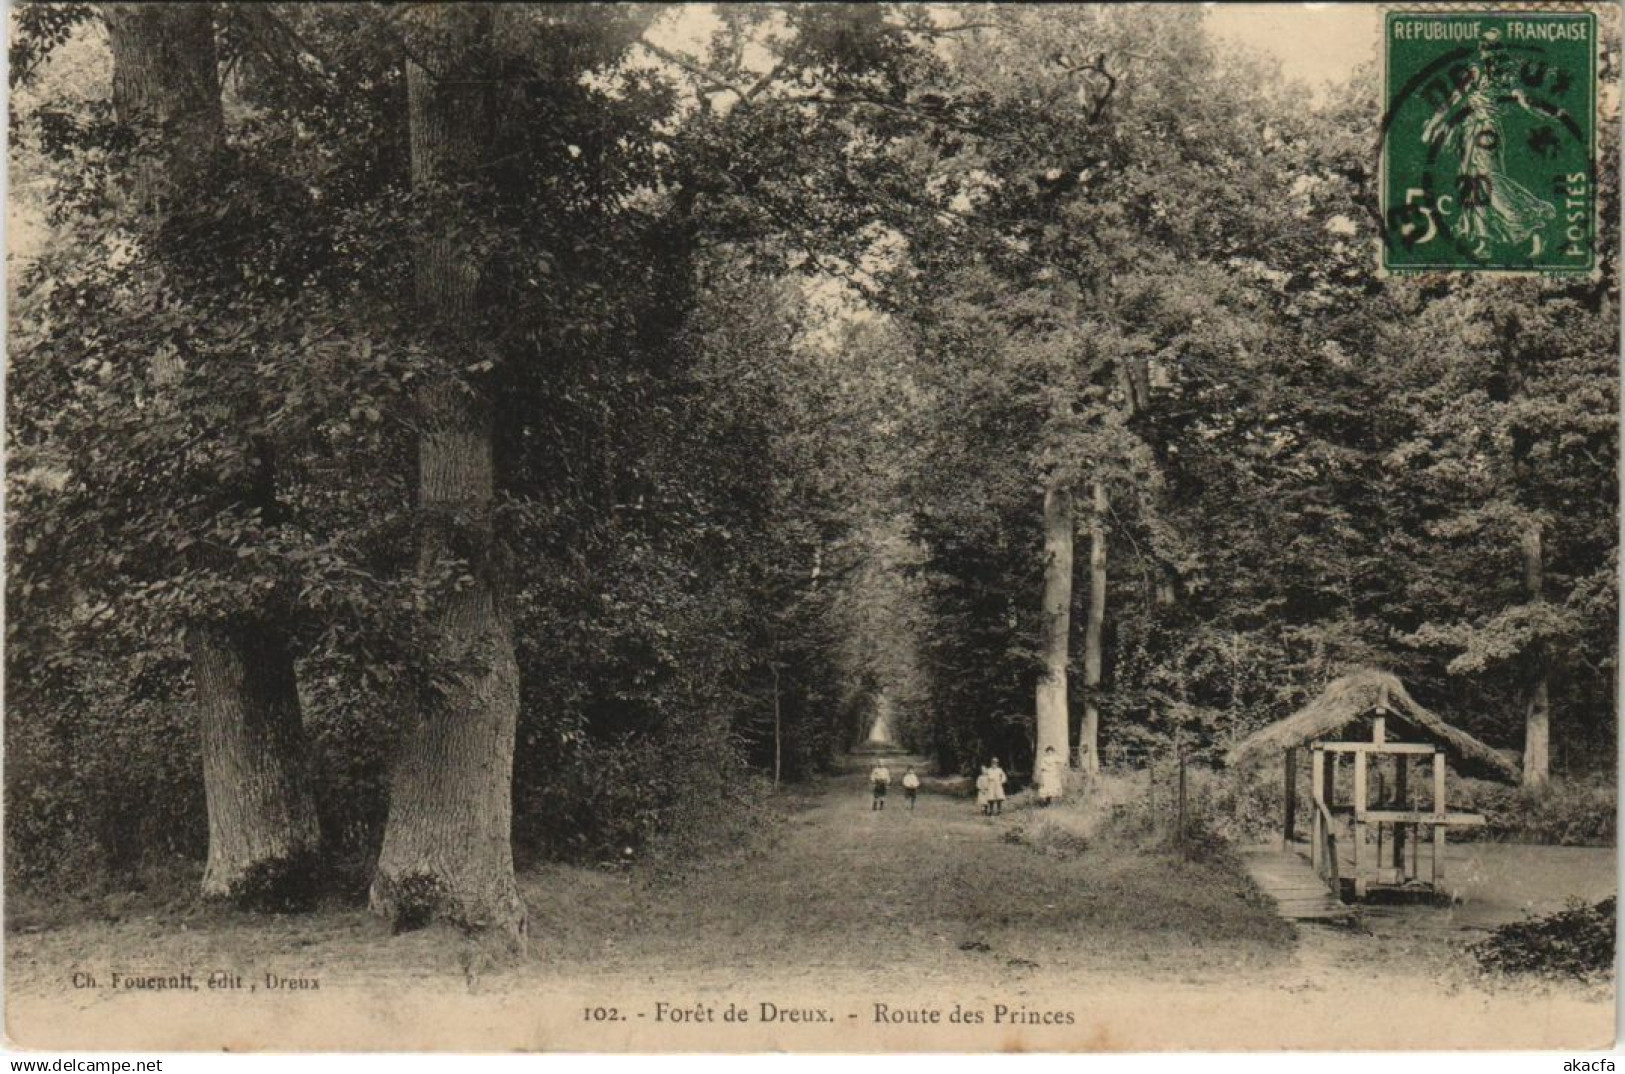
(7, 764), (1612, 1051)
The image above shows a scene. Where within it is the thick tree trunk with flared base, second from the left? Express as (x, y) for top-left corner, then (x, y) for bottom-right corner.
(372, 5), (525, 939)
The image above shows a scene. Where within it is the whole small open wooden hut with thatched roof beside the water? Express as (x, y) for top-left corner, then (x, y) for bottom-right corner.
(1229, 668), (1518, 899)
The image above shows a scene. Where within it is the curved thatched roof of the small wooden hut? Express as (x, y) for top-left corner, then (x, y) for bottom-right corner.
(1227, 668), (1518, 782)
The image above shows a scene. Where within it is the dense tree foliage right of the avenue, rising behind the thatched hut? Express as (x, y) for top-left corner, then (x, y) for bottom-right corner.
(910, 8), (1619, 775)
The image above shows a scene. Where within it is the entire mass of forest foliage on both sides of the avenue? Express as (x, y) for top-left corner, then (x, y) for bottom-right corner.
(5, 3), (1619, 890)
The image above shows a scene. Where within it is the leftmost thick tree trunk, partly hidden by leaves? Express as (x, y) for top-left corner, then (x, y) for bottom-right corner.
(104, 3), (320, 910)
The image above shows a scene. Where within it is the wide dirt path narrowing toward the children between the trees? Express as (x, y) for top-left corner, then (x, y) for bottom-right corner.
(527, 757), (1131, 980)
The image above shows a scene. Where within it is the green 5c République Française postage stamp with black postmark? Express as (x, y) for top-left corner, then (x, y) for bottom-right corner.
(1381, 10), (1597, 273)
